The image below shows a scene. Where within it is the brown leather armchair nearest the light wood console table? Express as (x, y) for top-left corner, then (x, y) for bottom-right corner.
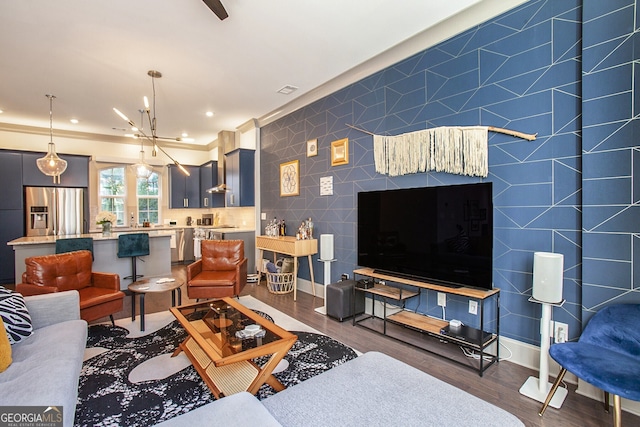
(187, 240), (247, 299)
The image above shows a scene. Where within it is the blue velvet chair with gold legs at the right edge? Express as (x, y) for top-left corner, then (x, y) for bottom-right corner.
(539, 304), (640, 427)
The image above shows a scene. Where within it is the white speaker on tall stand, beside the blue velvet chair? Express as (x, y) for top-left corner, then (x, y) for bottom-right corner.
(532, 252), (564, 304)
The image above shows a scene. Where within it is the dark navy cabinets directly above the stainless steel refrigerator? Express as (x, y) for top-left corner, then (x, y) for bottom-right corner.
(22, 152), (89, 188)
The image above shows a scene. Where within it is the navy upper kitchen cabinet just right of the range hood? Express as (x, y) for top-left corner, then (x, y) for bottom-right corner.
(225, 148), (255, 207)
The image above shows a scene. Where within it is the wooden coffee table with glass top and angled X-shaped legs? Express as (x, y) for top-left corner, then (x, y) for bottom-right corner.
(171, 298), (298, 399)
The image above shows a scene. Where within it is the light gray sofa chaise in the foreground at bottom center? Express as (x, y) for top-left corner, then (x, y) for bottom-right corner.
(158, 352), (524, 427)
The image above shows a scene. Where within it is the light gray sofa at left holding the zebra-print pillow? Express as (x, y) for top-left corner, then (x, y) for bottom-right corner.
(0, 291), (87, 426)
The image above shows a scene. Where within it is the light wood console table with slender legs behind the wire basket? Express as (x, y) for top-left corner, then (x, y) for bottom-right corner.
(256, 236), (318, 301)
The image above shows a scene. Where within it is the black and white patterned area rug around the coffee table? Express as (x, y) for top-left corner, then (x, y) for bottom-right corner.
(75, 313), (357, 426)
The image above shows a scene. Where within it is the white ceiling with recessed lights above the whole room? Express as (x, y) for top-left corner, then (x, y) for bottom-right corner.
(0, 0), (508, 145)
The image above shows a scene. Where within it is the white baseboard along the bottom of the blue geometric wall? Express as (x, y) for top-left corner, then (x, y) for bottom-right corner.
(298, 279), (640, 416)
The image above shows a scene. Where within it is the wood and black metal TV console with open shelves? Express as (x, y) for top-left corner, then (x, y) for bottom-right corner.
(353, 268), (500, 376)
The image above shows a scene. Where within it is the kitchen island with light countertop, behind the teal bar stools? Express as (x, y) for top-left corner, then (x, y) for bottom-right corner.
(7, 229), (175, 290)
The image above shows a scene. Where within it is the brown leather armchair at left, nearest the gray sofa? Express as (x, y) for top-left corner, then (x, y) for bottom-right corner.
(16, 250), (124, 323)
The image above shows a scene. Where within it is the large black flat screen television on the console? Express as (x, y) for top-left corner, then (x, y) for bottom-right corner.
(357, 182), (493, 289)
